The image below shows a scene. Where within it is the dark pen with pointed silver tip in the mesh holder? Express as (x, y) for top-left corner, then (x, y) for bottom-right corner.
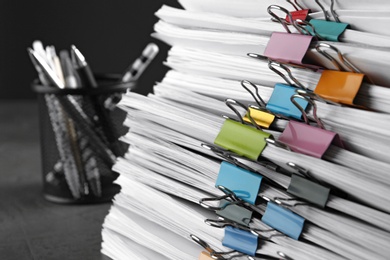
(71, 45), (123, 156)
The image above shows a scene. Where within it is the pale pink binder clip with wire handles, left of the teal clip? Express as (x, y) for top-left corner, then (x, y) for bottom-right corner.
(264, 5), (317, 68)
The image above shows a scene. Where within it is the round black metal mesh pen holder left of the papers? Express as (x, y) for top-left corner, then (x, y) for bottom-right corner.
(32, 74), (136, 204)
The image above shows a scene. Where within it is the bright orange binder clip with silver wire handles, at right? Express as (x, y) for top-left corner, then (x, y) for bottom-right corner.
(314, 43), (365, 107)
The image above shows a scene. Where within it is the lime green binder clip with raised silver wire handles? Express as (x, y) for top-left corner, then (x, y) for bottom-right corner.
(214, 99), (271, 160)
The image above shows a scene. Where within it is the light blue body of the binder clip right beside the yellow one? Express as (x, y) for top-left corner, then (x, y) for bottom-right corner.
(266, 83), (308, 120)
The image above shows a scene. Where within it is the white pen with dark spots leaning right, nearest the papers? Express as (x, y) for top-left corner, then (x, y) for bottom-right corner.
(121, 43), (159, 82)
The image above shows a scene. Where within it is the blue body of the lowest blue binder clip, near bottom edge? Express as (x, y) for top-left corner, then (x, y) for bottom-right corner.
(222, 227), (258, 256)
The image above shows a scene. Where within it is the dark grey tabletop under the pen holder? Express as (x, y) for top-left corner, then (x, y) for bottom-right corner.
(0, 100), (110, 260)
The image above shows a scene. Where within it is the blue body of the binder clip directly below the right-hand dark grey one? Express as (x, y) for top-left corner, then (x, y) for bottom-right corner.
(261, 202), (305, 240)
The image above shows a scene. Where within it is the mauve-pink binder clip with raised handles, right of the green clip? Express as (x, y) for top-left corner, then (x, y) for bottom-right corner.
(278, 94), (343, 159)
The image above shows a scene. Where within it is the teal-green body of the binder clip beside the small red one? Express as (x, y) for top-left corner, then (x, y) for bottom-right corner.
(306, 19), (349, 42)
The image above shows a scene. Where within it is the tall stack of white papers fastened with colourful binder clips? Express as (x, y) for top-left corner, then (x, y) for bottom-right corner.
(101, 0), (390, 260)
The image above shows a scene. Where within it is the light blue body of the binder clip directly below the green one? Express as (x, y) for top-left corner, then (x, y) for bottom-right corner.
(215, 161), (263, 204)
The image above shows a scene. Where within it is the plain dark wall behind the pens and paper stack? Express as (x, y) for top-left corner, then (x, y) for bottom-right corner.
(0, 0), (179, 99)
